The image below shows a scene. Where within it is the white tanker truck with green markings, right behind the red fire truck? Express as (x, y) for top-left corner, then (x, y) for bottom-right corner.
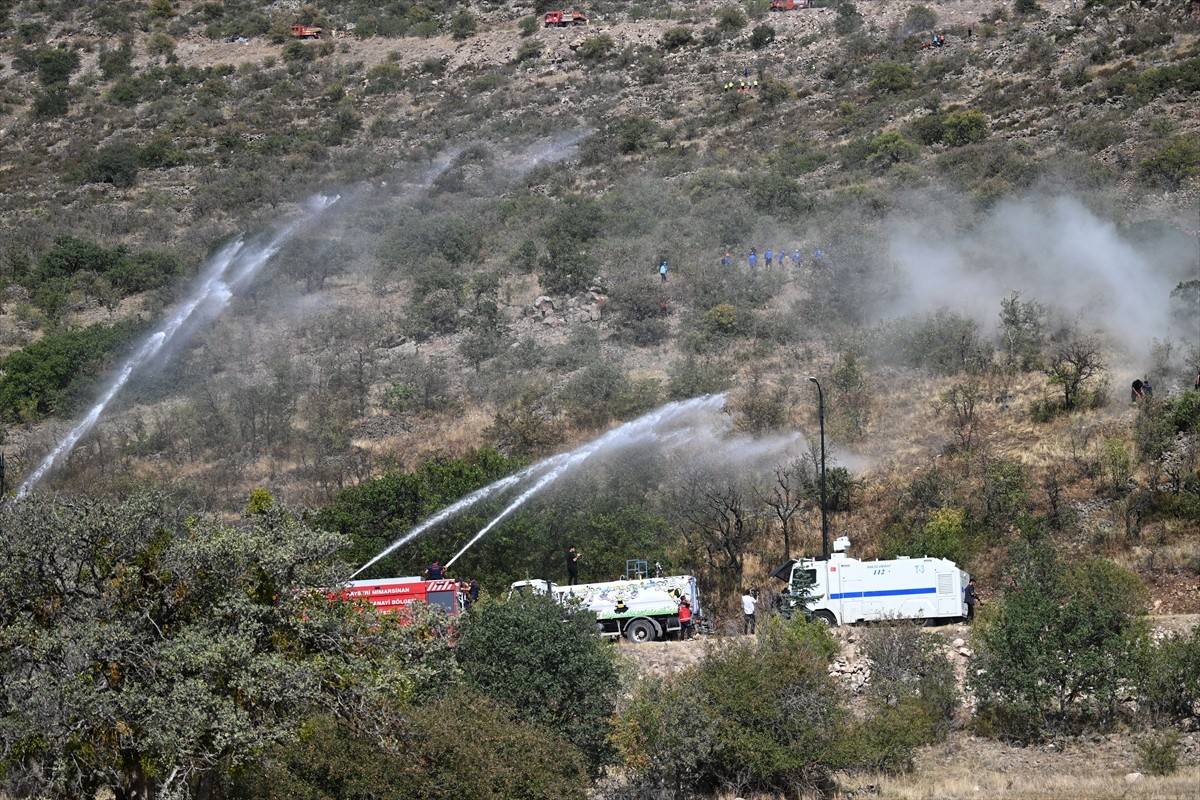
(509, 566), (703, 643)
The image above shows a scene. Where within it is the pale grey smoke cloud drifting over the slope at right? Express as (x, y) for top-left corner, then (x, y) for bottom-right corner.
(889, 197), (1200, 369)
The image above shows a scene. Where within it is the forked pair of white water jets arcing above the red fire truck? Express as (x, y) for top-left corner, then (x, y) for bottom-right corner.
(350, 395), (725, 578)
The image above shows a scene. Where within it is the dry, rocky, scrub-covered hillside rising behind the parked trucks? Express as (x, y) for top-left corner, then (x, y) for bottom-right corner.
(0, 2), (1200, 594)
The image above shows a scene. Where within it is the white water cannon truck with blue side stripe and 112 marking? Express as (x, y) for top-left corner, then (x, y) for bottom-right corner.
(770, 536), (971, 626)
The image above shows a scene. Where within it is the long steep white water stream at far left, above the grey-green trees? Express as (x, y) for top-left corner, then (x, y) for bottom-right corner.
(17, 196), (338, 498)
